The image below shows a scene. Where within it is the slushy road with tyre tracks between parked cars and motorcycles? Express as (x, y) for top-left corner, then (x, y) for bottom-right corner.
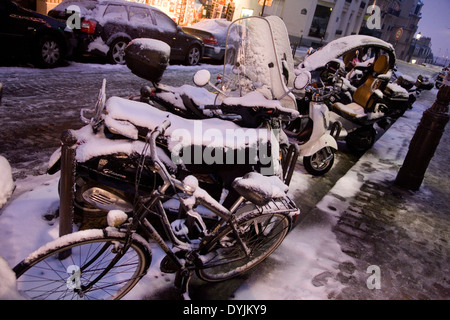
(0, 63), (214, 178)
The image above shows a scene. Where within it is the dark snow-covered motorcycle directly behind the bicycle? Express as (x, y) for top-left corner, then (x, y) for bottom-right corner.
(48, 18), (306, 228)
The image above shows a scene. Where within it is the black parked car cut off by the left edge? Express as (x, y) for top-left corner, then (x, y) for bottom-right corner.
(0, 0), (76, 68)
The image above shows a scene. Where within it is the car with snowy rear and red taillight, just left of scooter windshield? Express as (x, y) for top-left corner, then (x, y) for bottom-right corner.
(183, 19), (231, 61)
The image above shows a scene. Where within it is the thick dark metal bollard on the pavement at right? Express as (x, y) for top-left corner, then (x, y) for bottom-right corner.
(395, 77), (450, 191)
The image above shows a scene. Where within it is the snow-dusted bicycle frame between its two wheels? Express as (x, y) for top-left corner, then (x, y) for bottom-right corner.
(106, 121), (297, 294)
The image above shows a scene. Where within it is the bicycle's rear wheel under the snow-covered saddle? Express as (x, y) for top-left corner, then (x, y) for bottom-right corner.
(197, 212), (290, 282)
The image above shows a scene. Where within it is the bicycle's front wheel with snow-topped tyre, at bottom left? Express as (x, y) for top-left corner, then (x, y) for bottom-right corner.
(14, 230), (151, 300)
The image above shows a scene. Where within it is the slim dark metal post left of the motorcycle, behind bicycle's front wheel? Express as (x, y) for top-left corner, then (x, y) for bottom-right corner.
(59, 130), (77, 237)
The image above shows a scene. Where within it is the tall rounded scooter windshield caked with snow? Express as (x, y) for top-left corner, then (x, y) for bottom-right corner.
(222, 16), (296, 109)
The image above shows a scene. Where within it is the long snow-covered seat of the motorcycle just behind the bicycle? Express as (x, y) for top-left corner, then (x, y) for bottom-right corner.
(104, 97), (278, 151)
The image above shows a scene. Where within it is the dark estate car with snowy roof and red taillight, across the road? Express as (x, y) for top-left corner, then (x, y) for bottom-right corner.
(49, 0), (203, 65)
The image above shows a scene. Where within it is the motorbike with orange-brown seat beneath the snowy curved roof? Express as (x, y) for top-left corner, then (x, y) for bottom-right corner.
(304, 54), (430, 153)
